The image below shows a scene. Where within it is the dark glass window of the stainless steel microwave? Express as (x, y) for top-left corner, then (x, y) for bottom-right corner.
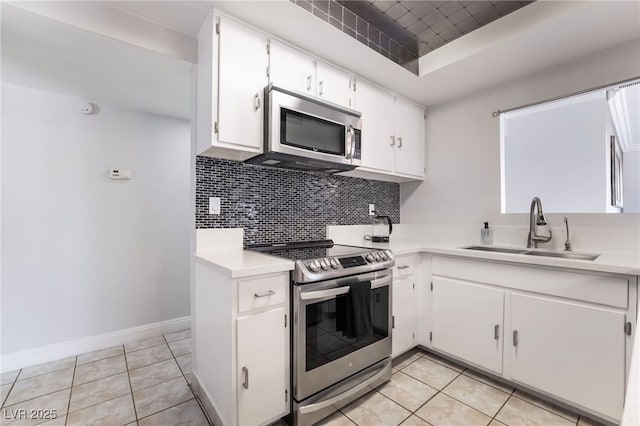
(280, 108), (345, 156)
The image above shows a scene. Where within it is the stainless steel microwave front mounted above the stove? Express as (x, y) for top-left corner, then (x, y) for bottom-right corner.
(266, 86), (361, 166)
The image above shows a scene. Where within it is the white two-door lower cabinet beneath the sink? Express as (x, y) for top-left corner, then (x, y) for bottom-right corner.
(427, 256), (638, 423)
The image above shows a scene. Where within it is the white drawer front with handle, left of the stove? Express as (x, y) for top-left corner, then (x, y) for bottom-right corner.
(238, 274), (289, 312)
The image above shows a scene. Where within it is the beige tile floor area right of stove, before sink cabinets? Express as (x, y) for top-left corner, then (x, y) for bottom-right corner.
(320, 350), (599, 426)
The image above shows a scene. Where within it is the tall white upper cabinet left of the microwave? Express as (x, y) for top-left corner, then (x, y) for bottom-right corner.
(196, 16), (268, 160)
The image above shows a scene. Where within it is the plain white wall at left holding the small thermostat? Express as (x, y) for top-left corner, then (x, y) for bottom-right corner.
(1, 84), (193, 354)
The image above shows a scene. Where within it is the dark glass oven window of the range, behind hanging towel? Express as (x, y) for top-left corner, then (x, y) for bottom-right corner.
(305, 286), (389, 371)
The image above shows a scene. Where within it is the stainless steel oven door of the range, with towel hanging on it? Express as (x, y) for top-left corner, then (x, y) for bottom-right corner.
(293, 269), (392, 401)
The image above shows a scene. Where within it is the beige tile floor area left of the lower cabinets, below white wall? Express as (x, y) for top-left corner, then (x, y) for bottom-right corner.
(0, 330), (210, 426)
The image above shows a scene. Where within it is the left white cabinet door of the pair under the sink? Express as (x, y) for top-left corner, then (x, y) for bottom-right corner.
(431, 277), (504, 374)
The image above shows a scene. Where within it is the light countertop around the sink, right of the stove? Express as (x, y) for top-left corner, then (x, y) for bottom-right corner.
(335, 236), (640, 275)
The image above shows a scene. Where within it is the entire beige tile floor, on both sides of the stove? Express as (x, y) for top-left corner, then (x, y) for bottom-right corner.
(0, 340), (598, 426)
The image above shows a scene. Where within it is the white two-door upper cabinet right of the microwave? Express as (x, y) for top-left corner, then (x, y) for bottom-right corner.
(349, 80), (425, 180)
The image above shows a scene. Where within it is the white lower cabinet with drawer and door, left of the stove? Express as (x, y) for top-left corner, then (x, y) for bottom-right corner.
(192, 262), (291, 426)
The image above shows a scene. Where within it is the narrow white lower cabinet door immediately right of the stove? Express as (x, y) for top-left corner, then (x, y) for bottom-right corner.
(391, 275), (417, 357)
